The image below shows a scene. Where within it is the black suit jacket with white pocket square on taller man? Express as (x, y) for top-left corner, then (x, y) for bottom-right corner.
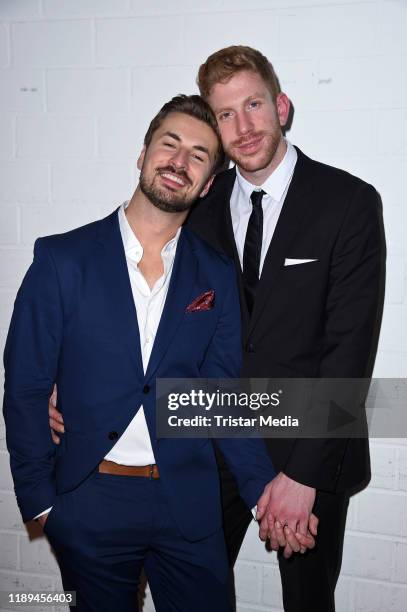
(188, 149), (384, 491)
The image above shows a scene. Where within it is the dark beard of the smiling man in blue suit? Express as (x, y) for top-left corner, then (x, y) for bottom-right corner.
(139, 166), (196, 213)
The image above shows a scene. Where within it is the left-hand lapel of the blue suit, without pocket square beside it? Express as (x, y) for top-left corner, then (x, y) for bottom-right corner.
(97, 210), (144, 380)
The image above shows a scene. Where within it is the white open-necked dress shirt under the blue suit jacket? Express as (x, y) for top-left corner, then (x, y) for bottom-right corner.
(35, 202), (181, 518)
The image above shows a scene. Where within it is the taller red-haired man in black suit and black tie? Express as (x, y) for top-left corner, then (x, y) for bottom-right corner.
(188, 46), (383, 612)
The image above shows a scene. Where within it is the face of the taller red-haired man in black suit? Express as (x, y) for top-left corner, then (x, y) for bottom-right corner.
(207, 70), (290, 184)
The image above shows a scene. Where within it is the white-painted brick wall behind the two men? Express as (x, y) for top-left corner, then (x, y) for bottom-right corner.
(0, 0), (407, 612)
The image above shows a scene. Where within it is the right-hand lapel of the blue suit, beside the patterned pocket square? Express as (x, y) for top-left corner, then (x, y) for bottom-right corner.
(146, 228), (197, 379)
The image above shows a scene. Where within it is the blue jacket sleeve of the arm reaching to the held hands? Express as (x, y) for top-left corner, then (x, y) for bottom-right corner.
(201, 263), (276, 508)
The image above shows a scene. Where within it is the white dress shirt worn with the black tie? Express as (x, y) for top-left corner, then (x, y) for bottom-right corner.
(230, 140), (298, 276)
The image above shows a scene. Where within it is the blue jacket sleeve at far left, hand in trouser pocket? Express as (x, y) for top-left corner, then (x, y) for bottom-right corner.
(3, 239), (63, 521)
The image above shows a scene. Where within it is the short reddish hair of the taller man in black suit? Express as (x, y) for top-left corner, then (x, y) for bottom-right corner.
(197, 45), (281, 100)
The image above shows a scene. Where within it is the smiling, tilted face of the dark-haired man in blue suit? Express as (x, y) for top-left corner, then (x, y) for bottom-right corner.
(137, 112), (218, 212)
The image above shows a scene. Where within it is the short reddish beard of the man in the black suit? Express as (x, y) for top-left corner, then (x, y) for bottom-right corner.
(225, 131), (281, 172)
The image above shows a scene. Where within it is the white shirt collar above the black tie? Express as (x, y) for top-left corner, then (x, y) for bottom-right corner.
(236, 140), (298, 202)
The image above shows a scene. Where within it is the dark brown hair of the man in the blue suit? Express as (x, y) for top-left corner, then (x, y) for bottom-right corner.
(144, 94), (225, 172)
